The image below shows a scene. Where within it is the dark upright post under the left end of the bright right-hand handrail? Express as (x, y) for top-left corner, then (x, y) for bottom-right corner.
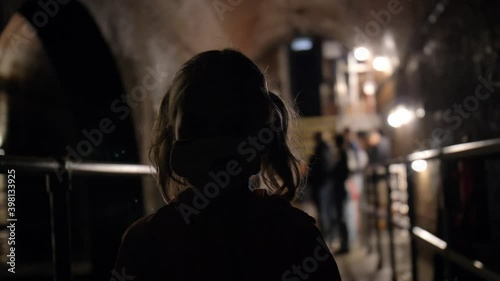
(405, 163), (418, 281)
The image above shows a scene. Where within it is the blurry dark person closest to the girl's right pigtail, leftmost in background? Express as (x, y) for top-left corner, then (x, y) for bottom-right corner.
(308, 132), (334, 236)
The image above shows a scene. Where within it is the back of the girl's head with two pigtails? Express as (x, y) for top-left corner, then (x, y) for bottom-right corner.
(150, 49), (303, 201)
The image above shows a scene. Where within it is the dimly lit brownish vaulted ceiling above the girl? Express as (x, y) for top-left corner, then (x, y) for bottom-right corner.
(0, 0), (432, 160)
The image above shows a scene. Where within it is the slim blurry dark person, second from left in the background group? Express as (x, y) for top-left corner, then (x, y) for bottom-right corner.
(333, 135), (349, 254)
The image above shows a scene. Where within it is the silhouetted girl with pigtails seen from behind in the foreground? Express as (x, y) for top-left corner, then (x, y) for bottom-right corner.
(114, 50), (340, 281)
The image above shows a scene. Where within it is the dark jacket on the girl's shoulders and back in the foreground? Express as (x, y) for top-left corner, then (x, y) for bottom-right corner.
(115, 185), (341, 281)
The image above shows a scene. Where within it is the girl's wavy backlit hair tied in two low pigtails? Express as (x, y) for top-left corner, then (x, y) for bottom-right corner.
(149, 49), (305, 203)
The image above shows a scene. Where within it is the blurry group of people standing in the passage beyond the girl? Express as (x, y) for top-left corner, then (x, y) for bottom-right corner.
(308, 128), (369, 254)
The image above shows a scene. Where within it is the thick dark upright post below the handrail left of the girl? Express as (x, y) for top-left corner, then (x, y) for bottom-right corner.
(47, 167), (71, 281)
